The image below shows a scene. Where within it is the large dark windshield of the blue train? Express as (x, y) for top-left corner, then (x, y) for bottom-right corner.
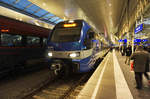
(51, 27), (81, 42)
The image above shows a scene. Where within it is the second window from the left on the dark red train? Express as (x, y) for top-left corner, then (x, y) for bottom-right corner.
(27, 36), (40, 46)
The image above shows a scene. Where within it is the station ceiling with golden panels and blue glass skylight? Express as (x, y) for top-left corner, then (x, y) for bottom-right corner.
(0, 0), (150, 44)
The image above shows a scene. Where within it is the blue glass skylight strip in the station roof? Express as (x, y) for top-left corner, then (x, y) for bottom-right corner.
(0, 0), (63, 25)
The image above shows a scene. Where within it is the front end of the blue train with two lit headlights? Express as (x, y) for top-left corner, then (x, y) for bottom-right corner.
(47, 20), (92, 75)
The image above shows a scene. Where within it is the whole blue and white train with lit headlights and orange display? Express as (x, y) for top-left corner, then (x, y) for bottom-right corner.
(47, 20), (107, 75)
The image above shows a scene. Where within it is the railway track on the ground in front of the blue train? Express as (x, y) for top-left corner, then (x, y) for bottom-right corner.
(24, 72), (93, 99)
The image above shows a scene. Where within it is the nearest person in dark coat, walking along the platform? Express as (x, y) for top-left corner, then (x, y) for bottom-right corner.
(131, 46), (150, 89)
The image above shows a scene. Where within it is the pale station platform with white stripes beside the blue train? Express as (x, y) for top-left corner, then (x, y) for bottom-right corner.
(77, 50), (150, 99)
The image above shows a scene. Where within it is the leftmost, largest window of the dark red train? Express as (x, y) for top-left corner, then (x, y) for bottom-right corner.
(1, 34), (22, 47)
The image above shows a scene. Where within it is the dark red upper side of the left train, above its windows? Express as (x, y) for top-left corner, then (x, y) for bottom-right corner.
(0, 16), (51, 37)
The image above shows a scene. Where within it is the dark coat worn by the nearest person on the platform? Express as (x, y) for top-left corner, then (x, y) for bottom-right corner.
(131, 51), (150, 72)
